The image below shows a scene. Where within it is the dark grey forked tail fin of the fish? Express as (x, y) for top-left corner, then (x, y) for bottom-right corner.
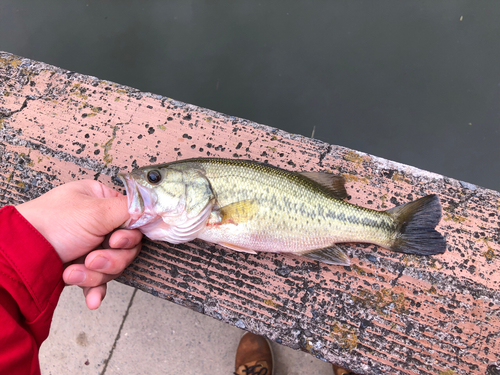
(386, 194), (446, 255)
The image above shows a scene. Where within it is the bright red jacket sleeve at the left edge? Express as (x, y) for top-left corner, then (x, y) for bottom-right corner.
(0, 206), (64, 374)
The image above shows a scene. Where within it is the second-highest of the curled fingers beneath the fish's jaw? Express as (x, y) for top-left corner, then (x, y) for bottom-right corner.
(85, 244), (141, 275)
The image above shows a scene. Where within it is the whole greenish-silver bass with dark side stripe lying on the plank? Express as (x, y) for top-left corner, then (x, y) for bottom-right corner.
(118, 158), (446, 265)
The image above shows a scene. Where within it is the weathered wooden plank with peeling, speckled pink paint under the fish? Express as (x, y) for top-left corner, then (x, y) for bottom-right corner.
(0, 53), (500, 374)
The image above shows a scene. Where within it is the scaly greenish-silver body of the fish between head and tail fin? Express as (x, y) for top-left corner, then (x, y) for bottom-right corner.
(193, 161), (394, 253)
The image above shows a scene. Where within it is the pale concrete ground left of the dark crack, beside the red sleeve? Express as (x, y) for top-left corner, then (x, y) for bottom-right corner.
(39, 282), (134, 375)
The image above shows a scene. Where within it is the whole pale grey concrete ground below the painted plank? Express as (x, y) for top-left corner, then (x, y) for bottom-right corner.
(40, 282), (333, 375)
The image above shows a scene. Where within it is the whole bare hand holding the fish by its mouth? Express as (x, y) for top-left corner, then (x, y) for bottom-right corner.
(16, 180), (142, 309)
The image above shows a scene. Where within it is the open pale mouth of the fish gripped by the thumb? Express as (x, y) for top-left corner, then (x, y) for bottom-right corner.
(118, 173), (157, 229)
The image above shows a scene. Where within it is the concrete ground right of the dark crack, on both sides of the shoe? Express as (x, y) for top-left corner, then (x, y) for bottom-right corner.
(105, 288), (333, 375)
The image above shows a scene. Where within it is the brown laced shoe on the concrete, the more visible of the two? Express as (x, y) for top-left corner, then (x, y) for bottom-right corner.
(234, 332), (273, 375)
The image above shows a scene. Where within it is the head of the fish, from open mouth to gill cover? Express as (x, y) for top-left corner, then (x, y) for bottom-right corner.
(118, 164), (215, 243)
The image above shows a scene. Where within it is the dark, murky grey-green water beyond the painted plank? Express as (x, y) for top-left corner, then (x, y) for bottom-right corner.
(0, 0), (500, 190)
